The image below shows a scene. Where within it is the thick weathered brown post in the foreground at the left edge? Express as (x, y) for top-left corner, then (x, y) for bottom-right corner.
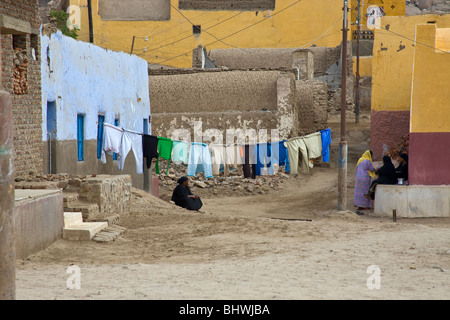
(0, 28), (16, 300)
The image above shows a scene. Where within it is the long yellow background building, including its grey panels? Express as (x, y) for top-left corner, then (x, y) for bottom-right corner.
(70, 0), (348, 67)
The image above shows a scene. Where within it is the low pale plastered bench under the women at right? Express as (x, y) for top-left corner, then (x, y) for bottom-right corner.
(374, 185), (450, 218)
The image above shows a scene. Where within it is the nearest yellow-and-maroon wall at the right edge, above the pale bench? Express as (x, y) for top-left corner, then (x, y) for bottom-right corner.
(409, 24), (450, 185)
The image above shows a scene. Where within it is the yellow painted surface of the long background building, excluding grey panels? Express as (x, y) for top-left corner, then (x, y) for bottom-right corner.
(70, 0), (350, 67)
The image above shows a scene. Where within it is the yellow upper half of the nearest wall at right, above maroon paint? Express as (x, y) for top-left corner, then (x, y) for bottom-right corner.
(411, 25), (450, 132)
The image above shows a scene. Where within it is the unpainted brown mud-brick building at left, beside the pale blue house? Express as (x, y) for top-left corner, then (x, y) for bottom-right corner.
(0, 0), (43, 180)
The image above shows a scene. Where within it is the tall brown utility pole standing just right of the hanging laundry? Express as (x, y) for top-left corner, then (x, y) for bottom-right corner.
(338, 0), (348, 210)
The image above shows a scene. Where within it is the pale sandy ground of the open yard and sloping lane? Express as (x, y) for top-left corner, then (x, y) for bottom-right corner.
(16, 117), (450, 300)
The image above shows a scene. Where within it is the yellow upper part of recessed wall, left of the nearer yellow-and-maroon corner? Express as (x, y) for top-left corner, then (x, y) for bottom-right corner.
(372, 14), (450, 111)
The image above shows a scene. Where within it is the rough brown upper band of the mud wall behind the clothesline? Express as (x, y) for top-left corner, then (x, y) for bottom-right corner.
(149, 71), (288, 114)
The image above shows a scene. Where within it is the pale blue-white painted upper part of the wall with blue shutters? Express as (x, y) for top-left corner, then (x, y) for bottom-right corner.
(41, 31), (151, 141)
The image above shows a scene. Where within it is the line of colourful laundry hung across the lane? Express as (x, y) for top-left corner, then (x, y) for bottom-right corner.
(100, 123), (331, 178)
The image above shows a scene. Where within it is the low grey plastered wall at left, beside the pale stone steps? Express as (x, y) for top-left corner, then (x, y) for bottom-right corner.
(14, 189), (64, 259)
